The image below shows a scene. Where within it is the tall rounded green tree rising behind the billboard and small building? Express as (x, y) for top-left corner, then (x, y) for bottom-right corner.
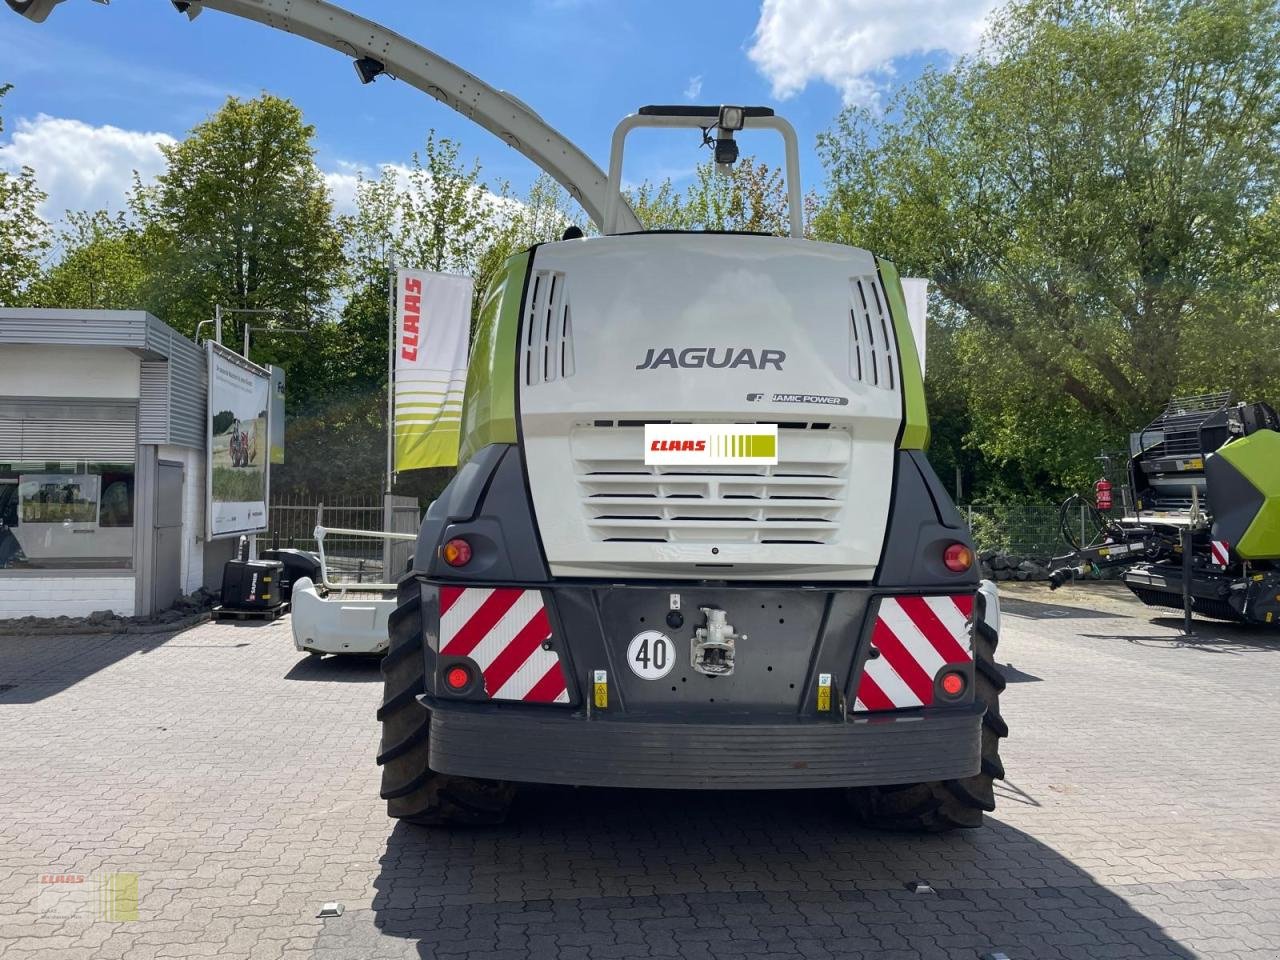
(133, 93), (343, 343)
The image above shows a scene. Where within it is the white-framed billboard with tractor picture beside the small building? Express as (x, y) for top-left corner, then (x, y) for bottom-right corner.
(207, 342), (271, 539)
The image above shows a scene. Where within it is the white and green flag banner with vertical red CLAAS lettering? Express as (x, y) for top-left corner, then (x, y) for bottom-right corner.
(394, 270), (472, 471)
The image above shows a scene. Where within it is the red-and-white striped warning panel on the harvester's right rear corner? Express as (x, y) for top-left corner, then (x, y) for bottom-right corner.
(854, 594), (973, 713)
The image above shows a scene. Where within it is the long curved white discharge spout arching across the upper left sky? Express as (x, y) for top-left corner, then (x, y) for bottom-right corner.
(6, 0), (640, 232)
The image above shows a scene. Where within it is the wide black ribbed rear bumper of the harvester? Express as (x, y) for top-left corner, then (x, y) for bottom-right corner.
(424, 698), (986, 790)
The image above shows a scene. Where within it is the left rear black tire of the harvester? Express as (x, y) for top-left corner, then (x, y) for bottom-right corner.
(378, 585), (516, 827)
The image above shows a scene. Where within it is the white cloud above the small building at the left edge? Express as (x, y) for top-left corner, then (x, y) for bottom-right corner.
(0, 114), (175, 220)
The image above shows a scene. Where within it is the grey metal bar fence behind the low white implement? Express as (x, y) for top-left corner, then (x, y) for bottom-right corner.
(257, 495), (420, 584)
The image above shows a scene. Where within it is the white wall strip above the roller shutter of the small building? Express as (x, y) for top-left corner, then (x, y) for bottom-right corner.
(0, 343), (142, 399)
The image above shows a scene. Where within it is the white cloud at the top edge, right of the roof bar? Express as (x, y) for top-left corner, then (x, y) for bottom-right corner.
(748, 0), (996, 104)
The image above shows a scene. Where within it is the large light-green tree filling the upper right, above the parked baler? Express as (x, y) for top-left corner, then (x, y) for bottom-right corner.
(817, 0), (1280, 492)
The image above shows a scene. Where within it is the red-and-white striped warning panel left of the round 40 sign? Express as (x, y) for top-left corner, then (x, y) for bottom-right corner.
(440, 586), (568, 703)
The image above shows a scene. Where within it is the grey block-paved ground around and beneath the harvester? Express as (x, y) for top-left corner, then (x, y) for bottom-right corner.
(0, 586), (1280, 960)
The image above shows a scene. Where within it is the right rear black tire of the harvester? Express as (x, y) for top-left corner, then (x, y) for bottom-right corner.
(849, 621), (1009, 833)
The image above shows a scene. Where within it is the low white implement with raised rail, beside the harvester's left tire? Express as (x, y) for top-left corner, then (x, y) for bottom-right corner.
(289, 526), (417, 654)
